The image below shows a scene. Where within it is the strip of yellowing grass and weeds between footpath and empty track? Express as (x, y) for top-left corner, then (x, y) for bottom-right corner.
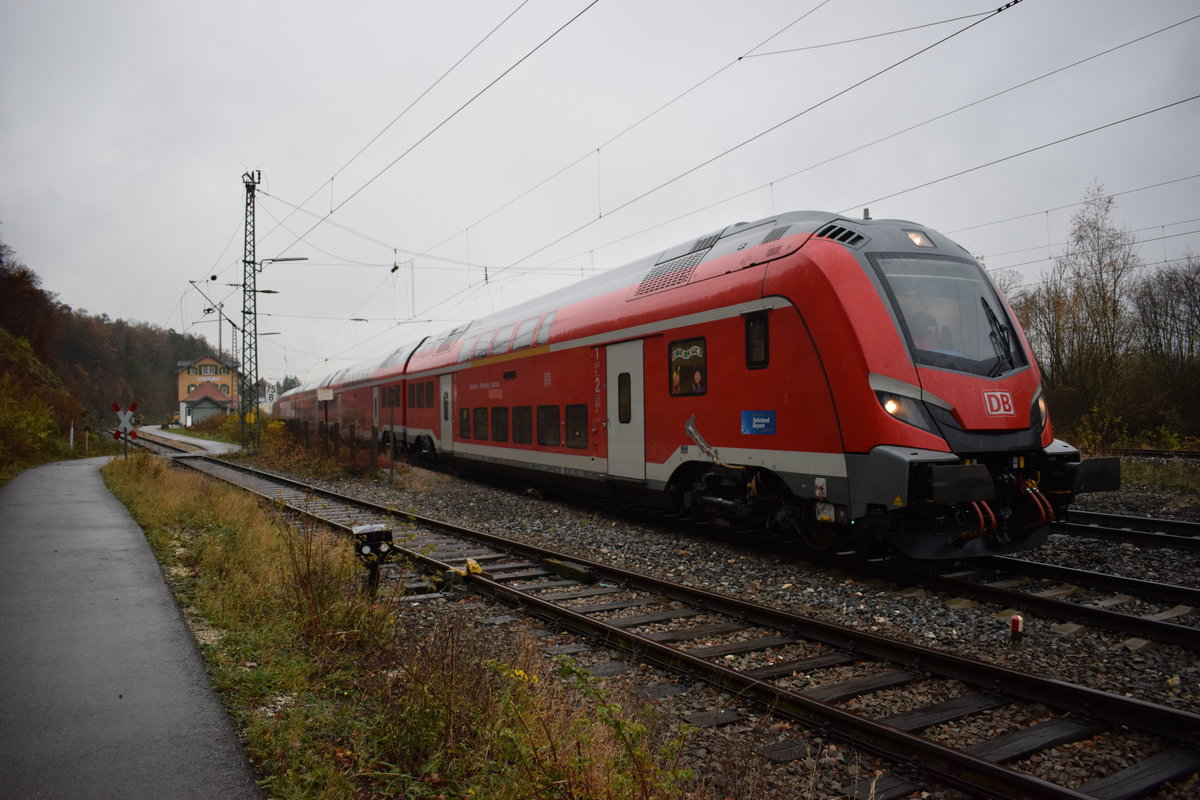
(104, 455), (696, 800)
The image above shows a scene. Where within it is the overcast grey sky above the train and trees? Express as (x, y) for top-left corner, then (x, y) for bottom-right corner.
(0, 0), (1200, 388)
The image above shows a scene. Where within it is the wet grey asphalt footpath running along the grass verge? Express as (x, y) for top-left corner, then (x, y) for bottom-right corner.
(0, 458), (263, 800)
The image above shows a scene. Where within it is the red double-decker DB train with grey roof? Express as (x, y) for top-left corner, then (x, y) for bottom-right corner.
(277, 211), (1120, 558)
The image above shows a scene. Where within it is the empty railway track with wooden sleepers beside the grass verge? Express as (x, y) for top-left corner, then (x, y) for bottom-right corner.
(131, 445), (1200, 800)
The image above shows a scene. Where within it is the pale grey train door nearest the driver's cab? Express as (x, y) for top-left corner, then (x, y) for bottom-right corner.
(605, 341), (646, 481)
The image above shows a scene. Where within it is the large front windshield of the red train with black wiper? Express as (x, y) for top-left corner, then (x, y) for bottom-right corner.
(871, 254), (1027, 378)
